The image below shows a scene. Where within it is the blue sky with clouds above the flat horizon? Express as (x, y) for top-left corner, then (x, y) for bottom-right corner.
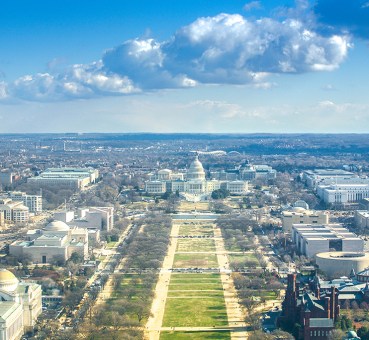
(0, 0), (369, 133)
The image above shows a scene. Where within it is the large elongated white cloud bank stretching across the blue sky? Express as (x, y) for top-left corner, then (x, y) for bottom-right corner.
(0, 12), (350, 101)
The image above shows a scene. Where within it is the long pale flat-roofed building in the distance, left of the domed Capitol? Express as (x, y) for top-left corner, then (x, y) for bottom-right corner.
(27, 168), (99, 189)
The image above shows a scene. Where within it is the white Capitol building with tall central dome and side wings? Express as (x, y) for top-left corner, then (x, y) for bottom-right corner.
(145, 155), (248, 201)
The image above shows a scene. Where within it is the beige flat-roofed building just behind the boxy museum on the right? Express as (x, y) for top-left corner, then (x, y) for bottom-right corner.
(282, 207), (329, 232)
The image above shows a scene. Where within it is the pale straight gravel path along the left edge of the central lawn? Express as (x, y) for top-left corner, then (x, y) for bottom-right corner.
(145, 223), (179, 340)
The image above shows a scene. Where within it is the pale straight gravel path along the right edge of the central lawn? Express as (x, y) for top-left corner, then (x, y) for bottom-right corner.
(214, 226), (248, 339)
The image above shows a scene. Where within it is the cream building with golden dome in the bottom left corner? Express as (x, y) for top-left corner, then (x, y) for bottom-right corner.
(0, 269), (42, 340)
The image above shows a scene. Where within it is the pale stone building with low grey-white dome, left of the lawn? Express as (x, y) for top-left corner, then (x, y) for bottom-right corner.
(9, 221), (88, 263)
